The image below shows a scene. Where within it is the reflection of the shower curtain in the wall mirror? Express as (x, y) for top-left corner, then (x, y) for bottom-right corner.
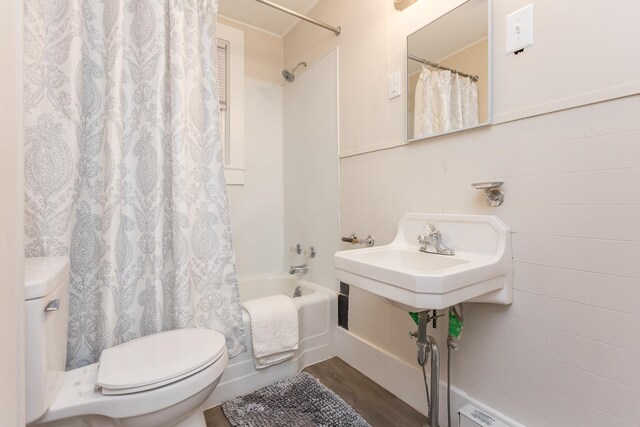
(413, 66), (478, 139)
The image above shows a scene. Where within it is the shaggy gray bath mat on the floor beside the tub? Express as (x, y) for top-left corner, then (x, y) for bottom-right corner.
(222, 372), (371, 427)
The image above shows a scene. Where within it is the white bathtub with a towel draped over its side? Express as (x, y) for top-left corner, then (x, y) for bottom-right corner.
(203, 274), (338, 409)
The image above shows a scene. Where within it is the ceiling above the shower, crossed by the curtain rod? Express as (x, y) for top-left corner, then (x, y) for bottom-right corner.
(218, 0), (319, 36)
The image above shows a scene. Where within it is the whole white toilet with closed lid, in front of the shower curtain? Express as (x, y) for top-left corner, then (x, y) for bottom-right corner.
(25, 257), (228, 427)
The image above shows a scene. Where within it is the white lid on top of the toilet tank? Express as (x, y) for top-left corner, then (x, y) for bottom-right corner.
(24, 256), (69, 300)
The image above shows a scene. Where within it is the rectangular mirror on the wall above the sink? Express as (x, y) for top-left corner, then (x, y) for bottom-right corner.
(406, 0), (491, 141)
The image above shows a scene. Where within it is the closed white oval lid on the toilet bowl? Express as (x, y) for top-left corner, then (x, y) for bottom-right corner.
(96, 328), (226, 394)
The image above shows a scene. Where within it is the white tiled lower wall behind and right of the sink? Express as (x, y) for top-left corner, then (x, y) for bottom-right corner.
(341, 95), (640, 426)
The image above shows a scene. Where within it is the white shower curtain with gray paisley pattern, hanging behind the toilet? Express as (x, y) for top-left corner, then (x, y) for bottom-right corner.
(24, 0), (244, 369)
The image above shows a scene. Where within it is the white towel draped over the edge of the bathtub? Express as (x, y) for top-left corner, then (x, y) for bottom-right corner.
(242, 295), (299, 369)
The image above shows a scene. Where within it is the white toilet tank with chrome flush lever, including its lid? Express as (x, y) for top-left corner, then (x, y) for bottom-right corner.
(24, 257), (69, 423)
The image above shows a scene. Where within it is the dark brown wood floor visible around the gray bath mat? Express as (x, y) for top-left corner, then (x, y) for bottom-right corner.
(204, 357), (427, 427)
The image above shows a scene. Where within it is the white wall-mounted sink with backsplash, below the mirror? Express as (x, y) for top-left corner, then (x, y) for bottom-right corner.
(335, 213), (513, 311)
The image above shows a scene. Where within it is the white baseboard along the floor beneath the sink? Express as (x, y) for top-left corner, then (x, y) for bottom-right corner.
(335, 328), (525, 427)
